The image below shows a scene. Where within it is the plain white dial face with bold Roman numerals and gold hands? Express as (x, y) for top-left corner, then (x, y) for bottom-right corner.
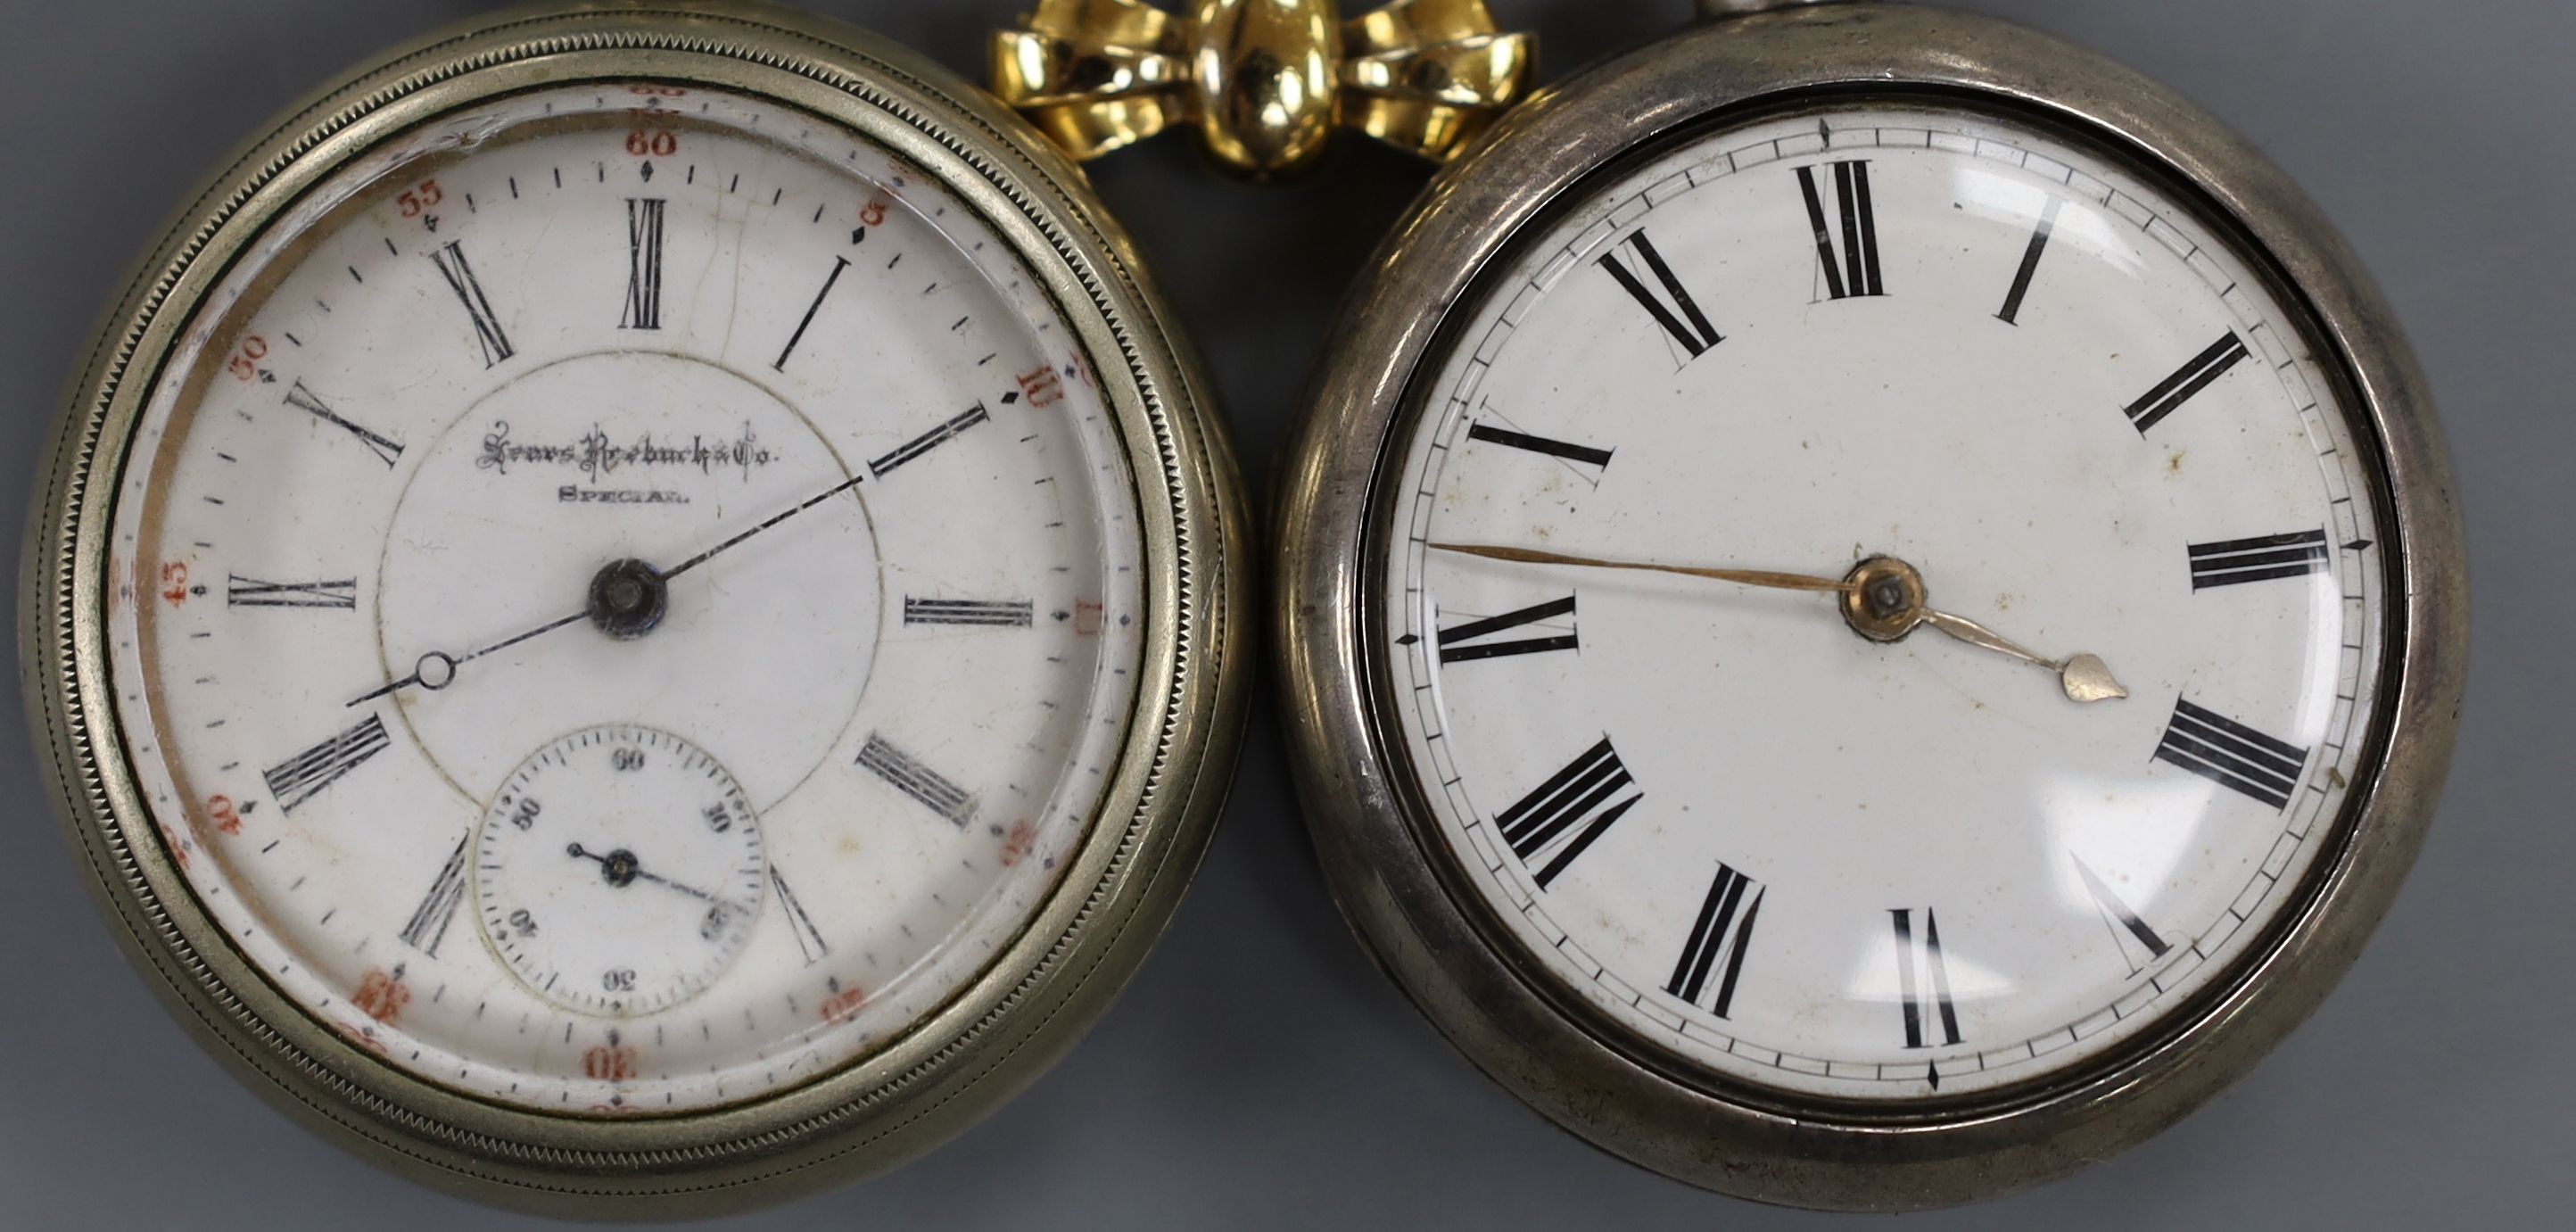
(1370, 103), (2390, 1101)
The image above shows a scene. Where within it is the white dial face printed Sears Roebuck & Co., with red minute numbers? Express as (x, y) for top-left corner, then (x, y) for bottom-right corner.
(108, 82), (1144, 1113)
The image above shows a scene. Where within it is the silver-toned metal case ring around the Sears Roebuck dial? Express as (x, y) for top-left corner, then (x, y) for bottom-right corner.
(18, 0), (1252, 1220)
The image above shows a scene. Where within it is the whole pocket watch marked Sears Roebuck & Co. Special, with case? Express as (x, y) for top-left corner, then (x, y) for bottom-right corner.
(21, 3), (1247, 1220)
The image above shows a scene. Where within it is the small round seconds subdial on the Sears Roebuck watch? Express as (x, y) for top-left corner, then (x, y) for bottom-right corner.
(474, 727), (771, 1018)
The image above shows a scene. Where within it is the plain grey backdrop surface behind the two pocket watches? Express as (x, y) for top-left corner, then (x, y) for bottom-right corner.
(0, 0), (2576, 1229)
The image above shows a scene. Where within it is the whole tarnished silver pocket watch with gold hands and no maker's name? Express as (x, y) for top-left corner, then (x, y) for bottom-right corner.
(1276, 0), (2465, 1209)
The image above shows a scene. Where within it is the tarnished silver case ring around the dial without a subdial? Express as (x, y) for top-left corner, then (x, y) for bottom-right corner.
(1273, 0), (2468, 1209)
